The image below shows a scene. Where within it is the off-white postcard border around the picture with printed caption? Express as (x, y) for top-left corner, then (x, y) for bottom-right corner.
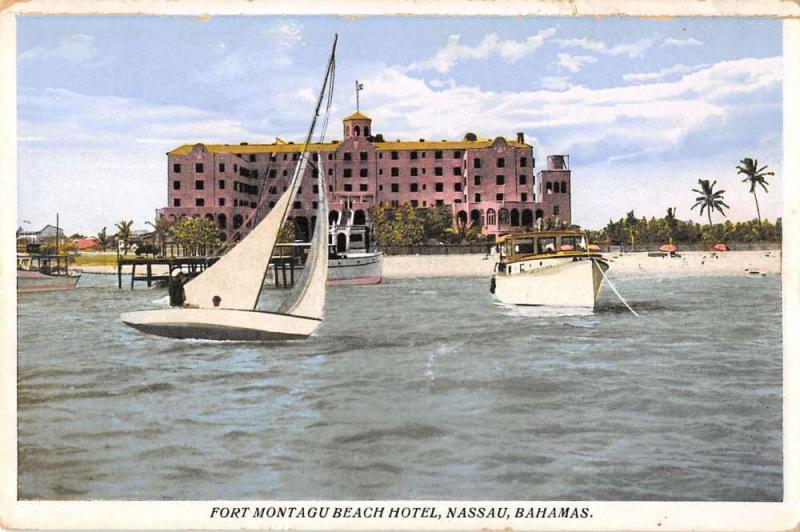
(0, 0), (800, 530)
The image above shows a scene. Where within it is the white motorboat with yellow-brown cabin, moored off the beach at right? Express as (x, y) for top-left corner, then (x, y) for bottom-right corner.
(491, 230), (608, 308)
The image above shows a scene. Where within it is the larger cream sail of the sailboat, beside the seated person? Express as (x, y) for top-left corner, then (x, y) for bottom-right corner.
(185, 157), (308, 310)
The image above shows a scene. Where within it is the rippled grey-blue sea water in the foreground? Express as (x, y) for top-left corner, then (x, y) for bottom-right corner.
(18, 275), (783, 501)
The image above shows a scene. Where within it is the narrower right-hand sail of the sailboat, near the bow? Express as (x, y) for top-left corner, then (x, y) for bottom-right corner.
(278, 157), (328, 319)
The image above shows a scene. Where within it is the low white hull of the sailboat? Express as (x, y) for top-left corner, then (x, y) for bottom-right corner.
(121, 307), (322, 342)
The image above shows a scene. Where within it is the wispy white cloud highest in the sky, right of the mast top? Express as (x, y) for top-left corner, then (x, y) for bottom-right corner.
(408, 28), (556, 74)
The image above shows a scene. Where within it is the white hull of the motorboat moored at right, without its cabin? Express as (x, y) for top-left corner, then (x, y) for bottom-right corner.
(494, 257), (608, 308)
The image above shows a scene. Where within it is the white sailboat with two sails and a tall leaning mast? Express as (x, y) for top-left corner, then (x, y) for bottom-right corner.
(121, 35), (338, 341)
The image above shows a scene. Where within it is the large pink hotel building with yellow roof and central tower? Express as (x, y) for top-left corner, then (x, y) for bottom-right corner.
(158, 113), (572, 240)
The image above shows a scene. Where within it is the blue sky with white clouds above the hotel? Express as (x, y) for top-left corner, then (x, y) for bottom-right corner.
(17, 16), (783, 234)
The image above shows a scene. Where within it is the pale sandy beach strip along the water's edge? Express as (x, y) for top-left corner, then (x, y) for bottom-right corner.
(72, 250), (782, 279)
